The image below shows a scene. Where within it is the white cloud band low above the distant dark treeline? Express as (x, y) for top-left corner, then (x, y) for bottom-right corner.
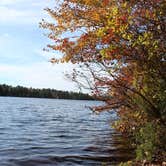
(0, 62), (77, 91)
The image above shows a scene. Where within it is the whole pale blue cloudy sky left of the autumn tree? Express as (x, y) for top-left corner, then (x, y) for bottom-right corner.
(0, 0), (77, 91)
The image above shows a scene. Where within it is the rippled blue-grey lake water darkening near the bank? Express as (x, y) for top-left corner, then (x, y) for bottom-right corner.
(0, 97), (131, 166)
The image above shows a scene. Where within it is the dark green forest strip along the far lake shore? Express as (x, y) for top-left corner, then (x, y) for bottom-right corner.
(0, 84), (93, 100)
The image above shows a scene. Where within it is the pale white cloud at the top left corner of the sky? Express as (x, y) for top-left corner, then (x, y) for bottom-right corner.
(0, 0), (51, 24)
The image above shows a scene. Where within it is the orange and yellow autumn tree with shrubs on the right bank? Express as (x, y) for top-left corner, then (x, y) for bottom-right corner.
(41, 0), (166, 165)
